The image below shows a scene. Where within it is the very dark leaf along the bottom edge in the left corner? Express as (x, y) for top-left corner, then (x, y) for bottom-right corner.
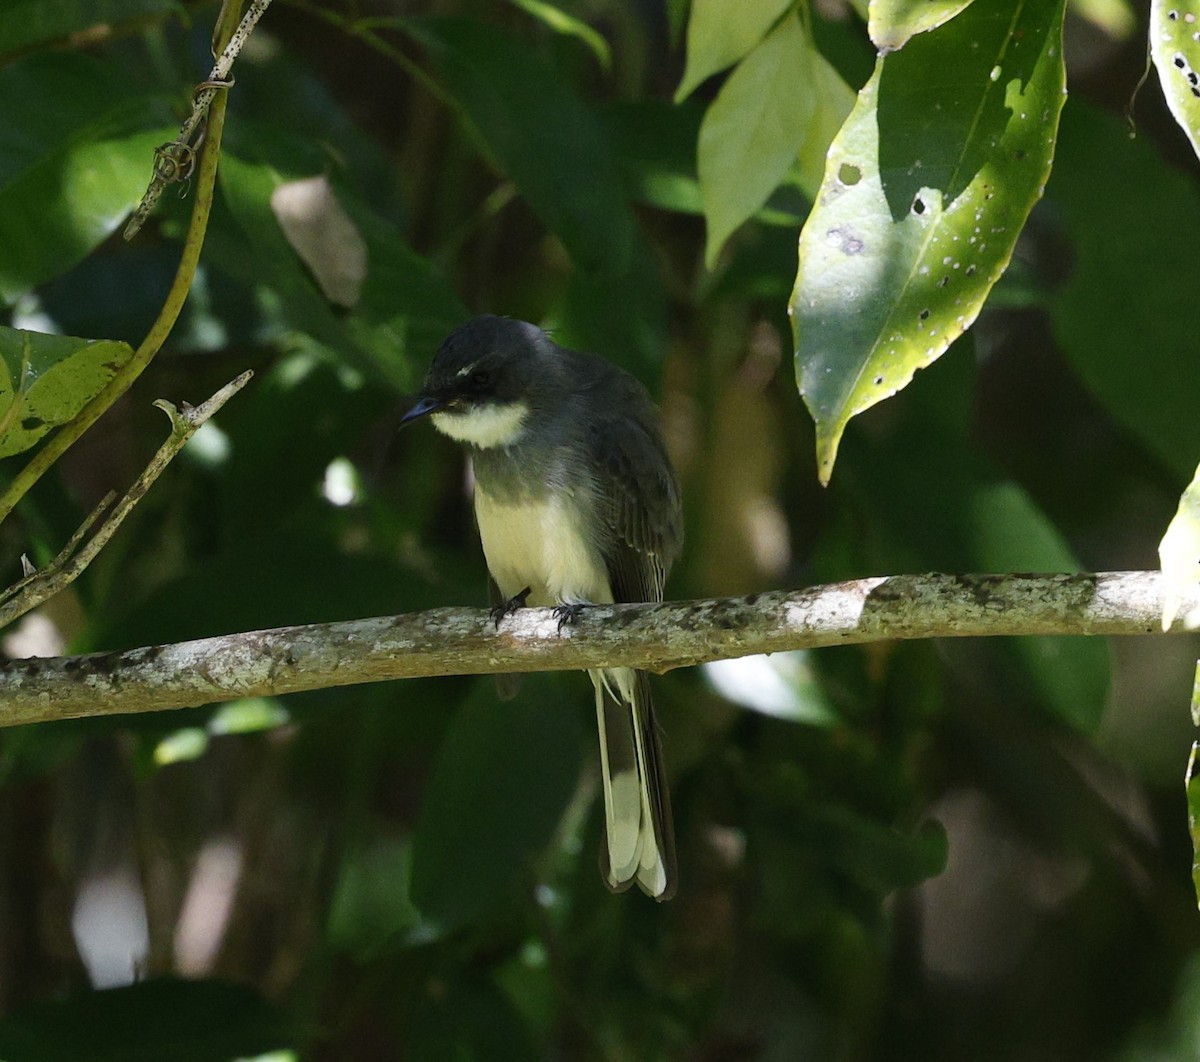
(0, 978), (295, 1062)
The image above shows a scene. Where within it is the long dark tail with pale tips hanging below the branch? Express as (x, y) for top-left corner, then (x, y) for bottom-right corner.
(590, 667), (677, 900)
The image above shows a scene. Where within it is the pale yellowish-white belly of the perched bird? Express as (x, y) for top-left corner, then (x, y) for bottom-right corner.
(475, 481), (612, 606)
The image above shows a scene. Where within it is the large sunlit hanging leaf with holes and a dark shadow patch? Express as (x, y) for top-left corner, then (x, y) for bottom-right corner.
(788, 0), (1066, 482)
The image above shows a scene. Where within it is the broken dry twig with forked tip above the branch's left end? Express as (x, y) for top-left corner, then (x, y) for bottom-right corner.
(0, 371), (253, 633)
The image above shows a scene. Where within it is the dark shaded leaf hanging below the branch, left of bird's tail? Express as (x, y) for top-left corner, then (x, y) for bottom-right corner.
(412, 682), (582, 930)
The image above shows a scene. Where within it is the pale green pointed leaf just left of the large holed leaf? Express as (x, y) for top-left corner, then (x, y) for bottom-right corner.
(698, 14), (854, 269)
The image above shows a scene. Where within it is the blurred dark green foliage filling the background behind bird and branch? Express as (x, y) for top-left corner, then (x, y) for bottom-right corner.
(0, 0), (1200, 1062)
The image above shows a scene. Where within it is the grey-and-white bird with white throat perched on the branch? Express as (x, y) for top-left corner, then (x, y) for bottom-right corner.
(401, 314), (683, 900)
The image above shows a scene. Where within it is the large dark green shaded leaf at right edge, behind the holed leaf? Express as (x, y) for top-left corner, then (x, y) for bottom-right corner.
(1048, 102), (1200, 482)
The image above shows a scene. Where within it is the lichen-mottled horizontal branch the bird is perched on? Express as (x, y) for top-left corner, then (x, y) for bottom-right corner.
(0, 571), (1200, 726)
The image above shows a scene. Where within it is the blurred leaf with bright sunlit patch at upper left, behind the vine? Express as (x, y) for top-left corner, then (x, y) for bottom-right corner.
(0, 53), (174, 302)
